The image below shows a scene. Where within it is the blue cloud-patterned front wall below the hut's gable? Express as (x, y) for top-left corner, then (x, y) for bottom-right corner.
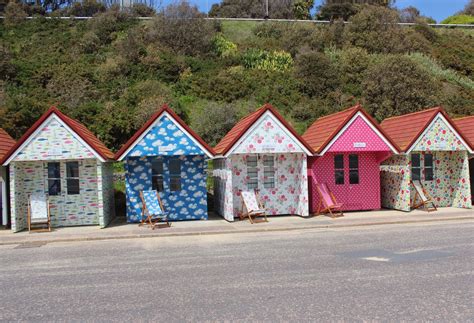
(125, 155), (207, 222)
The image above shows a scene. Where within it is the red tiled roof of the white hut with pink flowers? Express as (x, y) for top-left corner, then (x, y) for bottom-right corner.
(214, 103), (313, 155)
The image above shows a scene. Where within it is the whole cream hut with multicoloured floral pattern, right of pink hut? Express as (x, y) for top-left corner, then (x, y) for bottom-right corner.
(381, 107), (472, 211)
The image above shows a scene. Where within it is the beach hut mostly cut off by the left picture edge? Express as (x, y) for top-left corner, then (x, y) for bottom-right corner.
(0, 128), (15, 226)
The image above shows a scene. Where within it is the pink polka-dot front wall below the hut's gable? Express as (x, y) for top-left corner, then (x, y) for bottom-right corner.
(310, 152), (386, 213)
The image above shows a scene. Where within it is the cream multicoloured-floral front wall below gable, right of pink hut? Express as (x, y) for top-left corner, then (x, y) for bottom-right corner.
(411, 151), (472, 208)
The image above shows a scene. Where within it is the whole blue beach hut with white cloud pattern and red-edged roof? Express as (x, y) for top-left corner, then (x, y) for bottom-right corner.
(115, 105), (213, 222)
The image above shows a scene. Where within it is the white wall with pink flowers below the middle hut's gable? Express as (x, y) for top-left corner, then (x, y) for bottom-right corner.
(227, 153), (309, 217)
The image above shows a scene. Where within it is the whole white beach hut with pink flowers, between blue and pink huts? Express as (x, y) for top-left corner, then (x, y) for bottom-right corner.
(213, 104), (312, 221)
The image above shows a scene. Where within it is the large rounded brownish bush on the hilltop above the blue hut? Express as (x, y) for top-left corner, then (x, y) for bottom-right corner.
(147, 1), (215, 55)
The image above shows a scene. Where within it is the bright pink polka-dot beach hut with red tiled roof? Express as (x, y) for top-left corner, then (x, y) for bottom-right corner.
(303, 105), (398, 213)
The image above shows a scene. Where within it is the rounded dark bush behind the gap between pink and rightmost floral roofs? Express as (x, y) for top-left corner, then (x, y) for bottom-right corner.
(362, 55), (438, 120)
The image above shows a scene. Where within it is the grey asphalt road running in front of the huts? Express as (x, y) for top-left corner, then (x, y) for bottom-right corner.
(0, 222), (474, 322)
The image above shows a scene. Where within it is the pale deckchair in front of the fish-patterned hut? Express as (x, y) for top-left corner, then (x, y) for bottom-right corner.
(28, 193), (51, 233)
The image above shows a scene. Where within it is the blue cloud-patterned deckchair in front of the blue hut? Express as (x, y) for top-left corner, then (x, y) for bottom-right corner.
(139, 190), (171, 230)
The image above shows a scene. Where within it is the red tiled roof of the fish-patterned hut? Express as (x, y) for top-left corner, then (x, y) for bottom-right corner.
(1, 107), (114, 164)
